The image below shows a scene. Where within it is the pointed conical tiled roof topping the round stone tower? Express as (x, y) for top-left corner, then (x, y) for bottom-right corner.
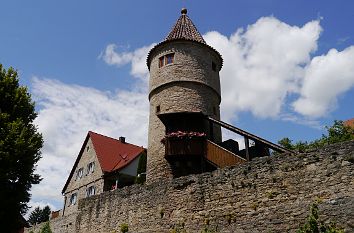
(165, 8), (206, 44)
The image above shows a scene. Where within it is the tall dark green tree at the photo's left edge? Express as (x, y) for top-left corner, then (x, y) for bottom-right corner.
(0, 64), (43, 232)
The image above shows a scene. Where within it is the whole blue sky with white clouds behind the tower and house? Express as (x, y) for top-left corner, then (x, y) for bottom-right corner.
(0, 0), (354, 213)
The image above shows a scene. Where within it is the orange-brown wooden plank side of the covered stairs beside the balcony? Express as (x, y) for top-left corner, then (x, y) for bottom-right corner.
(205, 140), (246, 168)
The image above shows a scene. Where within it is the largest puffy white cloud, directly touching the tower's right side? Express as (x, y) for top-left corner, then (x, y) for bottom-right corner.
(204, 17), (321, 120)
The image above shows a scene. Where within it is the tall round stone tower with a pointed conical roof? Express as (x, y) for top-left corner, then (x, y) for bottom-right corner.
(147, 9), (223, 183)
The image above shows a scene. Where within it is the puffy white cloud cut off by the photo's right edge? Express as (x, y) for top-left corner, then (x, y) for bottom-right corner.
(293, 46), (354, 117)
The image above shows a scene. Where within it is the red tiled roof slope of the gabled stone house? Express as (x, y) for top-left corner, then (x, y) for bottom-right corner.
(89, 131), (144, 172)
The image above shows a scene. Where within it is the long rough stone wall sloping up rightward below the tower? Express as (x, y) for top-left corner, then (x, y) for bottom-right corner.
(24, 141), (354, 233)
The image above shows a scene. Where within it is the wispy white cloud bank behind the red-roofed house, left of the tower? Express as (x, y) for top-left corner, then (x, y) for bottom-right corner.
(31, 77), (148, 208)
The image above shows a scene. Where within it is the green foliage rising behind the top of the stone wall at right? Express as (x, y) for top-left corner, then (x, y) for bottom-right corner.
(278, 120), (354, 152)
